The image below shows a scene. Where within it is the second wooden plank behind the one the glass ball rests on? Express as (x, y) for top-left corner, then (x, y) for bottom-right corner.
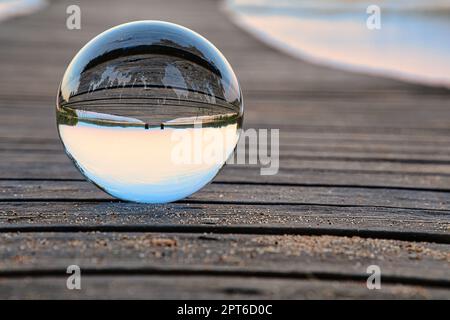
(0, 162), (450, 191)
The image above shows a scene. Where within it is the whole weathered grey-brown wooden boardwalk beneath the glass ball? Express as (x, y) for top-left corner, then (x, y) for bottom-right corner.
(0, 0), (450, 299)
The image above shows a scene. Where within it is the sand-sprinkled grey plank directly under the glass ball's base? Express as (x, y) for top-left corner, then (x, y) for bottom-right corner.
(0, 201), (450, 239)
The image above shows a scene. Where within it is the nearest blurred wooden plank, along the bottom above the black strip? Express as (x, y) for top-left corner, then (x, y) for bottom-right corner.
(0, 275), (448, 300)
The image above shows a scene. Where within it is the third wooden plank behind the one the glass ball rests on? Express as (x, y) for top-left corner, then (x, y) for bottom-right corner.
(4, 132), (450, 164)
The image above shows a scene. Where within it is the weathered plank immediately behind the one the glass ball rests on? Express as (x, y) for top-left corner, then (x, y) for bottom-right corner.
(0, 180), (450, 212)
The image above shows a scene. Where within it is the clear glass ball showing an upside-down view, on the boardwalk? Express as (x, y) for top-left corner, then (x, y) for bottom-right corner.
(56, 21), (243, 203)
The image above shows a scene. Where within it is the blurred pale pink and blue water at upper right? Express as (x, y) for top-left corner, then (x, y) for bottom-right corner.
(227, 0), (450, 87)
